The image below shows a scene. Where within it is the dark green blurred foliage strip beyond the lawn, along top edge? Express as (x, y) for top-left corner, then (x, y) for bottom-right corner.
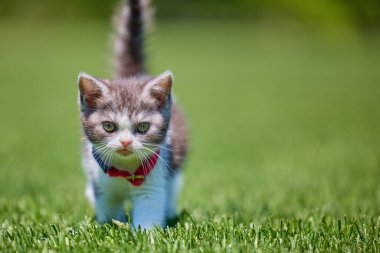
(0, 0), (380, 30)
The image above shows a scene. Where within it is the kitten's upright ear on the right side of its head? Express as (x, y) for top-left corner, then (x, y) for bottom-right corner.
(144, 70), (174, 105)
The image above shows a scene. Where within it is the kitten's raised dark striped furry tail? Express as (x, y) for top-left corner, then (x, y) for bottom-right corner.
(114, 0), (152, 78)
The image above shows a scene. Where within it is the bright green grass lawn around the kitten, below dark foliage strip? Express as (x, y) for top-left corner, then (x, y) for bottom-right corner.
(0, 20), (380, 252)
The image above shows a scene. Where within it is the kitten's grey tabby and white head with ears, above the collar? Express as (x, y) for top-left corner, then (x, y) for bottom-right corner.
(78, 71), (173, 168)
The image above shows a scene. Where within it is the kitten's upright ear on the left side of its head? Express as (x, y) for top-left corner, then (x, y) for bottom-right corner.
(78, 72), (108, 108)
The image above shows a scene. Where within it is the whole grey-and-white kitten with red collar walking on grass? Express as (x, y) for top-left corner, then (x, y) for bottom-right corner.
(78, 0), (187, 229)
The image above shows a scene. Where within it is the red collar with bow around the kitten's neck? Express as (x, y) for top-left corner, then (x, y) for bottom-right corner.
(107, 149), (160, 186)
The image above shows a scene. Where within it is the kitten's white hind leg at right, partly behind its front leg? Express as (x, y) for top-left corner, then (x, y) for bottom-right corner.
(166, 170), (182, 219)
